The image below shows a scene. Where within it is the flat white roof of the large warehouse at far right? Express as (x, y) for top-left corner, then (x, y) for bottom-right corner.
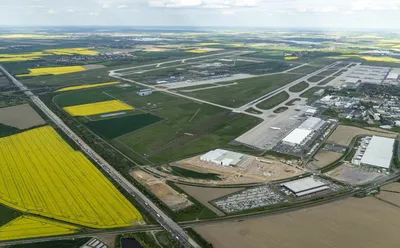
(361, 136), (394, 169)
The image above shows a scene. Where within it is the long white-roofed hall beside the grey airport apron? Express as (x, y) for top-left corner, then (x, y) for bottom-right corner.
(282, 117), (325, 146)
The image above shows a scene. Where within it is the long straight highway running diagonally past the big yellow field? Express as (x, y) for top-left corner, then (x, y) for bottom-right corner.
(0, 66), (200, 248)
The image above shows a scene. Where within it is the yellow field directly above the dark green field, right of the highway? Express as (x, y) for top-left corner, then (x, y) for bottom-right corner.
(64, 100), (134, 116)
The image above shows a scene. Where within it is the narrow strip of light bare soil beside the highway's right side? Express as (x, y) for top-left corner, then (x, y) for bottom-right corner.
(131, 170), (193, 211)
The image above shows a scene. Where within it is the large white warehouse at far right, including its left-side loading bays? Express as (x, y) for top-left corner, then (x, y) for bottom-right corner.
(352, 136), (395, 172)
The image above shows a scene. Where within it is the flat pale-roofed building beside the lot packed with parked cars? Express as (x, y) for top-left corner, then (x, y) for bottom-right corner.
(280, 177), (330, 197)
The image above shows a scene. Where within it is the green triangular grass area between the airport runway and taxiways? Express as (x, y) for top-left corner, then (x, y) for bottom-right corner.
(185, 73), (303, 107)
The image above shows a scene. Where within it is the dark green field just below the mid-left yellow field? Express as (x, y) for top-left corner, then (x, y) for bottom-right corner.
(85, 114), (162, 139)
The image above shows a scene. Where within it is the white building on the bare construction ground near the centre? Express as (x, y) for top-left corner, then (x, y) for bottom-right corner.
(200, 149), (247, 166)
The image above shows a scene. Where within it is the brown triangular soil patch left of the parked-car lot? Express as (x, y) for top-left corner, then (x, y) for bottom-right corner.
(176, 184), (244, 216)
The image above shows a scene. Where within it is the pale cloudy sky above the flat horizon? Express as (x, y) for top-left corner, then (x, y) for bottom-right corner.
(0, 0), (400, 30)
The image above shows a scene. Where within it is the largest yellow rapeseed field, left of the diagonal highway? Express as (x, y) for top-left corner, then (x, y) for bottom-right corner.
(0, 126), (142, 228)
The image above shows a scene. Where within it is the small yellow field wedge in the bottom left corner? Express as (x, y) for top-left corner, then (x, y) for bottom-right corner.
(0, 216), (80, 241)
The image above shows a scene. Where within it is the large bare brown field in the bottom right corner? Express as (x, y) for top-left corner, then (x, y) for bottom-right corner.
(194, 197), (400, 248)
